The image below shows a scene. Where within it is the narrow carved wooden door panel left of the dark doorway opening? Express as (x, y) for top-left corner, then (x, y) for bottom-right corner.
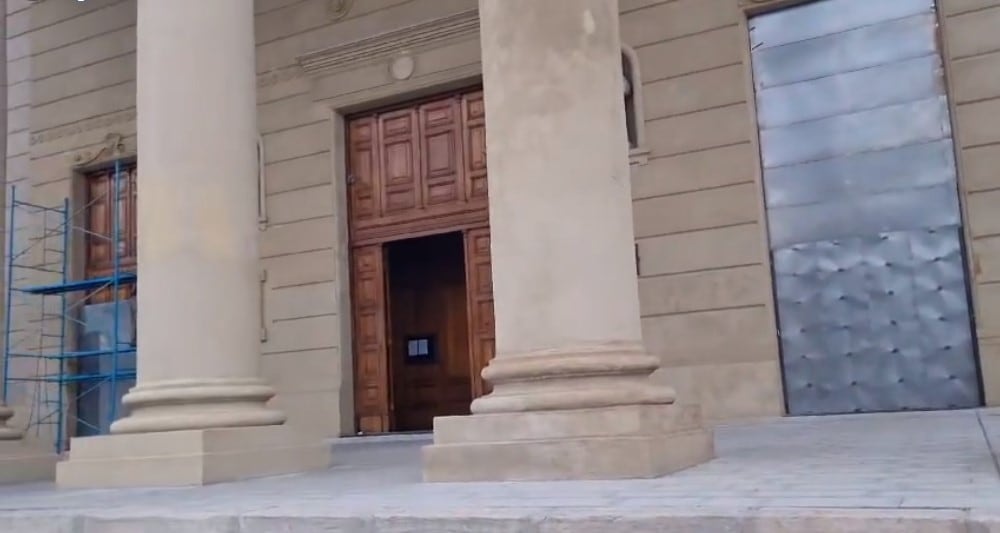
(351, 245), (392, 433)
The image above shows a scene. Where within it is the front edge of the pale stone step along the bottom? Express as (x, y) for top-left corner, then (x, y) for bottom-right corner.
(0, 507), (976, 533)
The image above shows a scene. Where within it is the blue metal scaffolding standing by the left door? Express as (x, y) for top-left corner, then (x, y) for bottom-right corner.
(3, 162), (136, 453)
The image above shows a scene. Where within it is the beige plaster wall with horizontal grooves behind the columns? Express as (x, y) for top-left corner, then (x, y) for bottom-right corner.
(8, 0), (1000, 435)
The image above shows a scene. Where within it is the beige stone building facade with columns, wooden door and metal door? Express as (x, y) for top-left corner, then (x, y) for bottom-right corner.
(0, 0), (1000, 485)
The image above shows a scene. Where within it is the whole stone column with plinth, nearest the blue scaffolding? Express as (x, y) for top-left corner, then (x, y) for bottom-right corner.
(57, 0), (329, 486)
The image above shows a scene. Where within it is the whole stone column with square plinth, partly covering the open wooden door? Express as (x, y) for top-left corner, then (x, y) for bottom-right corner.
(424, 0), (713, 481)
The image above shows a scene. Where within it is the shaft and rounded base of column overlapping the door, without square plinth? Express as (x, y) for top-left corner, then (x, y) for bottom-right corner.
(472, 0), (673, 413)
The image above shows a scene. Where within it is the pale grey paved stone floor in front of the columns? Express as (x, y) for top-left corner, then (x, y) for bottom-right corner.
(0, 411), (1000, 533)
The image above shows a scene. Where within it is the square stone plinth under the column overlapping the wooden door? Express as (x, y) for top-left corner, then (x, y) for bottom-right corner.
(423, 404), (715, 482)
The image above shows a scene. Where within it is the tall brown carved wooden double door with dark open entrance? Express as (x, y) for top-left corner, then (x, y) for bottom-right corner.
(347, 89), (494, 433)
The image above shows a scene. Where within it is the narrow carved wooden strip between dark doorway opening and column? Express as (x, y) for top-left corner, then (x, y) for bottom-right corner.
(465, 228), (496, 398)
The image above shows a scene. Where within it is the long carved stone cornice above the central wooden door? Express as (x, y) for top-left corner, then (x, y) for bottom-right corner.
(297, 10), (479, 76)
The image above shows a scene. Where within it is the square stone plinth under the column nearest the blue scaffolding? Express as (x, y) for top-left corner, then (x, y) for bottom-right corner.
(56, 425), (330, 488)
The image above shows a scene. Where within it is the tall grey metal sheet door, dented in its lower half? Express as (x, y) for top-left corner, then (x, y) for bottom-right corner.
(750, 0), (981, 414)
